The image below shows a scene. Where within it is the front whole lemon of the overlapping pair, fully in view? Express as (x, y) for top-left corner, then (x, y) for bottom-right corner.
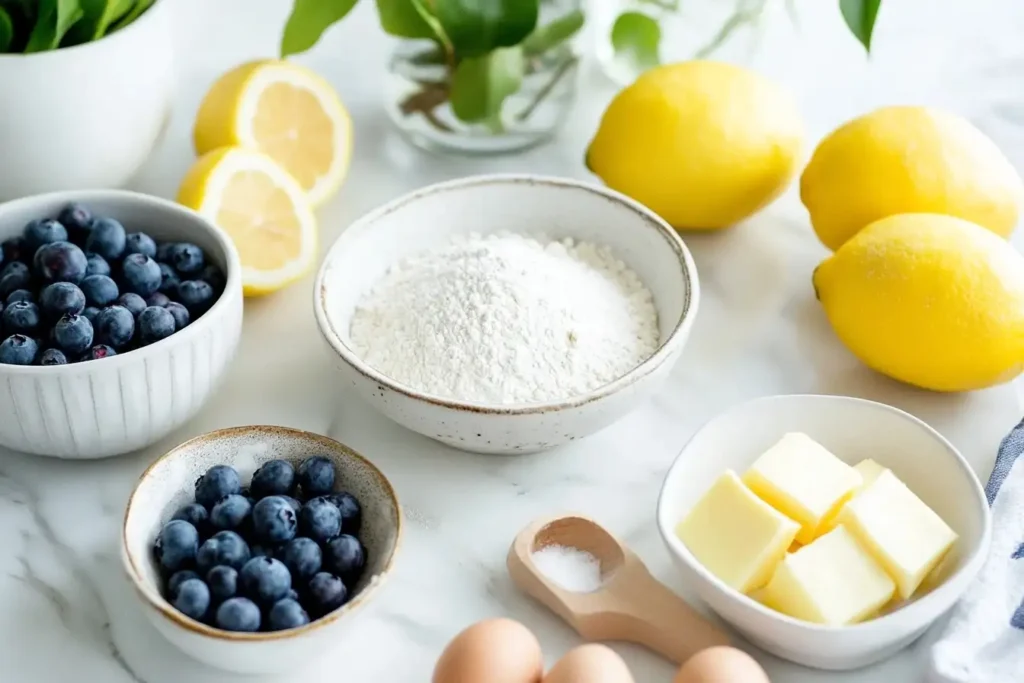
(813, 214), (1024, 391)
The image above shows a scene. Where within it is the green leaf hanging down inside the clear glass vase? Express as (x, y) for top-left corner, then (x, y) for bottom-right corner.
(450, 46), (526, 123)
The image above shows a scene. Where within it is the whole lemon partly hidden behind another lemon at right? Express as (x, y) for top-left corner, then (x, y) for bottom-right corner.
(800, 106), (1024, 250)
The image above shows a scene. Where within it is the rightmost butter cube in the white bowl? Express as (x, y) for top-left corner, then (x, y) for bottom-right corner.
(839, 470), (956, 599)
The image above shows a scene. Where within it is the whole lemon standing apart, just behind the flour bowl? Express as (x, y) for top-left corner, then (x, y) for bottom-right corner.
(587, 60), (803, 229)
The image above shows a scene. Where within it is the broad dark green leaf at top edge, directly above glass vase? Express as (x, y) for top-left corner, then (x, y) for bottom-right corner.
(433, 0), (540, 59)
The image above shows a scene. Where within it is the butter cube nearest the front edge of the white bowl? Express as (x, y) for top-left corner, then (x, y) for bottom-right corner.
(759, 526), (896, 626)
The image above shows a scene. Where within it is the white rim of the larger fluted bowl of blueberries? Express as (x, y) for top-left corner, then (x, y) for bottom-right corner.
(0, 189), (242, 376)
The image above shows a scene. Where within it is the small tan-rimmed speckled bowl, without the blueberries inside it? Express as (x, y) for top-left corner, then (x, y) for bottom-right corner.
(121, 427), (401, 674)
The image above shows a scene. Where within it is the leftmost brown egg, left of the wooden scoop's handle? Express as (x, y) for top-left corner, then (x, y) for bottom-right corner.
(431, 618), (544, 683)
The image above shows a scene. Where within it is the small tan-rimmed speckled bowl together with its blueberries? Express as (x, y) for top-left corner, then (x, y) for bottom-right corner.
(122, 427), (401, 673)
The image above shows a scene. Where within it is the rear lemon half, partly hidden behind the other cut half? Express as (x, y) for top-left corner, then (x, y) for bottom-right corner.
(194, 59), (352, 207)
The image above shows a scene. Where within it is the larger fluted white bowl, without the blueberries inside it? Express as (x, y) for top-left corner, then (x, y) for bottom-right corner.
(0, 190), (242, 459)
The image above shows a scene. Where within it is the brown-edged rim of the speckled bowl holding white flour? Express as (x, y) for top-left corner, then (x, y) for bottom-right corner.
(313, 173), (700, 415)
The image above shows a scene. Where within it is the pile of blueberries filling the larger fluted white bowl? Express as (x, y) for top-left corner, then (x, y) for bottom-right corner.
(0, 204), (224, 366)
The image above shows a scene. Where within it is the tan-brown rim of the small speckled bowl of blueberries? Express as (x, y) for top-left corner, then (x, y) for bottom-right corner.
(121, 425), (403, 642)
